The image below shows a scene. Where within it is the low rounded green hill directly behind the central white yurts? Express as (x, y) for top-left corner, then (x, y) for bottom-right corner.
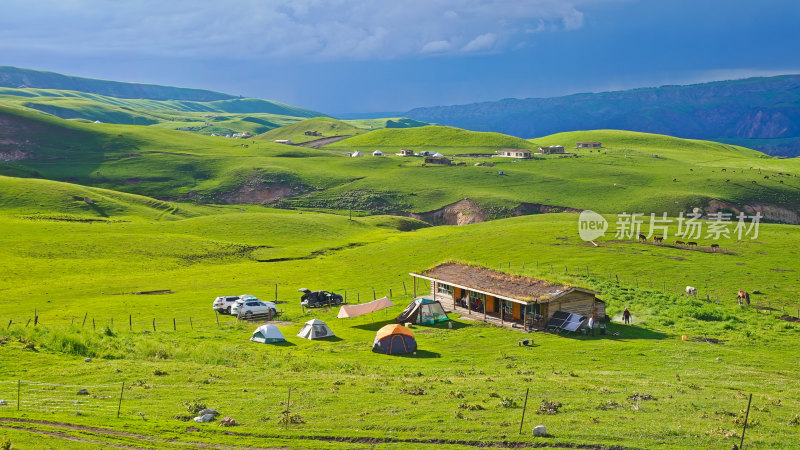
(327, 125), (535, 150)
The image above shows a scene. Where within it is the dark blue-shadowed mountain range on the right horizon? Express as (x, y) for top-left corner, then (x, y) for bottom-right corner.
(404, 75), (800, 156)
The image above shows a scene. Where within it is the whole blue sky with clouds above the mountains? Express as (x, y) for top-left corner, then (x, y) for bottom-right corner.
(0, 0), (800, 114)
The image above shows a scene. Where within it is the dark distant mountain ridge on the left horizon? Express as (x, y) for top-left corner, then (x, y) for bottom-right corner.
(0, 66), (238, 102)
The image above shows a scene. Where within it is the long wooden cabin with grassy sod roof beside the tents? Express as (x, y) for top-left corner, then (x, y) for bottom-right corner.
(410, 263), (606, 329)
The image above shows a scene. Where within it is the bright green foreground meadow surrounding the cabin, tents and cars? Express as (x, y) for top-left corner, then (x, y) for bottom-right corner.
(0, 202), (800, 448)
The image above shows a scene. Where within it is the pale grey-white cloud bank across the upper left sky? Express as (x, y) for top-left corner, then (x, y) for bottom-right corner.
(0, 0), (609, 60)
